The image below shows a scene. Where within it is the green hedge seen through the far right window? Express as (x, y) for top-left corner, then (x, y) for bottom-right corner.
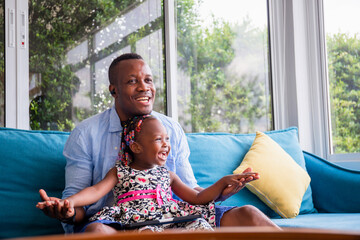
(327, 33), (360, 153)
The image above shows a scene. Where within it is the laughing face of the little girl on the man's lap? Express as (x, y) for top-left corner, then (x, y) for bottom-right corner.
(131, 118), (170, 170)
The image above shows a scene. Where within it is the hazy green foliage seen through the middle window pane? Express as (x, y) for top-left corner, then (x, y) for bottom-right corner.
(177, 0), (272, 133)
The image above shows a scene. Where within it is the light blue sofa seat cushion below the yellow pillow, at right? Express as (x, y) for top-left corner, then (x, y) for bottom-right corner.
(272, 213), (360, 231)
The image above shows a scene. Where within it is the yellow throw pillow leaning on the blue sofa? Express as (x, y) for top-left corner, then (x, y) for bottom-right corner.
(234, 132), (310, 218)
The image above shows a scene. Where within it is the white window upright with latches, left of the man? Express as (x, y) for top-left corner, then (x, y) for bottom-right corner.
(5, 0), (29, 129)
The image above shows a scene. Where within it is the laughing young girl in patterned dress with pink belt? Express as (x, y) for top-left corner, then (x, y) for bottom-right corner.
(37, 115), (258, 231)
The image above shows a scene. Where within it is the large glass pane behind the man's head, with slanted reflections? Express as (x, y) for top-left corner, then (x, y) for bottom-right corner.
(29, 0), (166, 131)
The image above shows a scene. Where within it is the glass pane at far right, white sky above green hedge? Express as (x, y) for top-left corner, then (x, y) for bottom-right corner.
(324, 0), (360, 153)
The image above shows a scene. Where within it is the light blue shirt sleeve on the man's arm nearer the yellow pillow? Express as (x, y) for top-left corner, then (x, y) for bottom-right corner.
(173, 122), (199, 188)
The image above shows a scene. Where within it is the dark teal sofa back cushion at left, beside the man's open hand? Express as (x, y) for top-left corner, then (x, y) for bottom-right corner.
(0, 128), (69, 238)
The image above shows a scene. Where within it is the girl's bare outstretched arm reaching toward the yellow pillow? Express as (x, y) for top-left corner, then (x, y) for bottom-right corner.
(170, 171), (259, 204)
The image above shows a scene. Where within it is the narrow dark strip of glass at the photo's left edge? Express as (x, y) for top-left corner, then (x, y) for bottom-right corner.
(0, 0), (5, 127)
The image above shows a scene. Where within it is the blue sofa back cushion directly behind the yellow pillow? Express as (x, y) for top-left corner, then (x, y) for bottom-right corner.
(187, 127), (316, 217)
